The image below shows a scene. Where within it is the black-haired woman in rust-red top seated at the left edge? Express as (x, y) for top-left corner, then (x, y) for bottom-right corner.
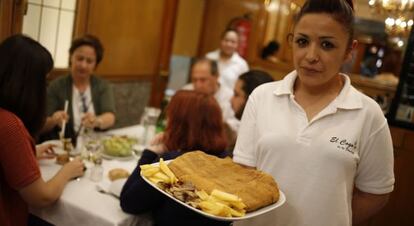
(0, 35), (84, 226)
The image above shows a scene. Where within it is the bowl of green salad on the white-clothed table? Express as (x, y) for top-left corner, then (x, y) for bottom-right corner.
(101, 135), (138, 160)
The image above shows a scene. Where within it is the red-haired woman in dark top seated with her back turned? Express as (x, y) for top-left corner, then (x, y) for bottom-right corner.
(120, 90), (230, 226)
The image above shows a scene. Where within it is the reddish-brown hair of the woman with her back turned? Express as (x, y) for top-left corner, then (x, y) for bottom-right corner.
(164, 90), (227, 153)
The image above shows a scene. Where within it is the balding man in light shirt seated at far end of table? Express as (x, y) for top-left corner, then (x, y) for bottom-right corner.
(183, 58), (239, 131)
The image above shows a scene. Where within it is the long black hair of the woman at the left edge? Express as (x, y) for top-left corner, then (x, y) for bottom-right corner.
(0, 34), (53, 137)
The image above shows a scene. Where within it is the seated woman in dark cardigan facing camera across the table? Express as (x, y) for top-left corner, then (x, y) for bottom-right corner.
(43, 35), (115, 141)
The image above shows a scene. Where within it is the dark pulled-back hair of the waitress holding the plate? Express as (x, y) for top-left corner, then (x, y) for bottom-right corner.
(294, 0), (354, 45)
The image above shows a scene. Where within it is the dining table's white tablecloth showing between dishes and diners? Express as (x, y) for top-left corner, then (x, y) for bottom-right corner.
(30, 125), (152, 226)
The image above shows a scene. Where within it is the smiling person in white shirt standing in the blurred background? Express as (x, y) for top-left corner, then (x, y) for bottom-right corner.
(206, 29), (249, 90)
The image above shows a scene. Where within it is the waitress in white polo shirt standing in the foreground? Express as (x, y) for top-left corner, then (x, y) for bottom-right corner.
(233, 0), (394, 226)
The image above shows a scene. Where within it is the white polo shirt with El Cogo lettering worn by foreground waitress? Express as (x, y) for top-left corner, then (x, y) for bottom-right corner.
(234, 71), (394, 226)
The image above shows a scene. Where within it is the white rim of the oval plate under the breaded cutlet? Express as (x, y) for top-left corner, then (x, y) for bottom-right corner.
(141, 160), (286, 221)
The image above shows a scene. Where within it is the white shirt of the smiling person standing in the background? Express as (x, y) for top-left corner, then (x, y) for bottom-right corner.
(206, 50), (249, 92)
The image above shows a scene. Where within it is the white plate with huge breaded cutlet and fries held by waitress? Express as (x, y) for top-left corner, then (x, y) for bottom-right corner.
(141, 151), (286, 221)
